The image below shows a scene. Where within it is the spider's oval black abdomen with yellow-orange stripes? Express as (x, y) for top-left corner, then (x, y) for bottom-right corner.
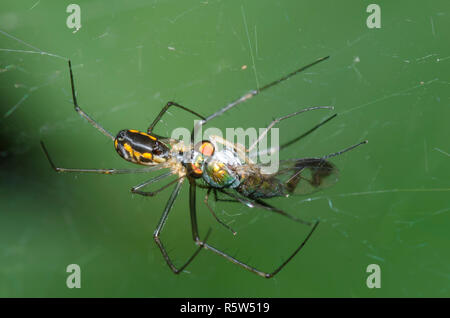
(114, 130), (170, 165)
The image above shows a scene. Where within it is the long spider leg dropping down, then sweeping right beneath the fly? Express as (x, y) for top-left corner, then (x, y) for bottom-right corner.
(189, 180), (319, 278)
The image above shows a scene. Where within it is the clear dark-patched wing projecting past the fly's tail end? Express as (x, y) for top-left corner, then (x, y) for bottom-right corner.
(261, 158), (339, 195)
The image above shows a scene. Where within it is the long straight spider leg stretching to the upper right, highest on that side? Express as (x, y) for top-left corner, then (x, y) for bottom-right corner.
(191, 56), (329, 141)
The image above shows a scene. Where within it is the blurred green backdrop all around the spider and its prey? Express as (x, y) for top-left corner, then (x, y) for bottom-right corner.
(0, 0), (450, 297)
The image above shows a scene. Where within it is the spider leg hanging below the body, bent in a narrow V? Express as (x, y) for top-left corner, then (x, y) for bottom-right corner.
(153, 178), (211, 274)
